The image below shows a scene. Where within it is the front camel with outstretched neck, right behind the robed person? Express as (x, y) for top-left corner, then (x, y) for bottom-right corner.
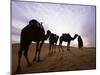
(59, 33), (78, 51)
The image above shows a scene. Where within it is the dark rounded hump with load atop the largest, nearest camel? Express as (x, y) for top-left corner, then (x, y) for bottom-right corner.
(29, 19), (44, 31)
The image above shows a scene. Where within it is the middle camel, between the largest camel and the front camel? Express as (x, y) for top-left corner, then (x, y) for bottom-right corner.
(48, 33), (59, 55)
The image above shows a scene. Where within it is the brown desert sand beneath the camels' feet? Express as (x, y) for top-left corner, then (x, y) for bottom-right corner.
(11, 43), (96, 73)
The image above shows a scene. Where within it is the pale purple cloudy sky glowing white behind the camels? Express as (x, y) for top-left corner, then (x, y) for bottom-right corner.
(11, 1), (96, 47)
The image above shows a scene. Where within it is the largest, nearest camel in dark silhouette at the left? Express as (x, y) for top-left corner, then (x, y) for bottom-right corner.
(17, 19), (51, 71)
